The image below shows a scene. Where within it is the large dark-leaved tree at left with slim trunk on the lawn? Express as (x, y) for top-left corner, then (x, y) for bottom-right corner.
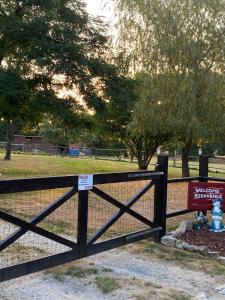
(0, 0), (114, 159)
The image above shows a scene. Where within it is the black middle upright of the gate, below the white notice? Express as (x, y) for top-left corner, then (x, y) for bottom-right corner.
(77, 191), (88, 257)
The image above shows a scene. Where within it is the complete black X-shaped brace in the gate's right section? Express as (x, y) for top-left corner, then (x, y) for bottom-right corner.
(88, 180), (155, 245)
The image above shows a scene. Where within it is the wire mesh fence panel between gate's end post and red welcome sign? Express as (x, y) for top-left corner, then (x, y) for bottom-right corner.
(167, 182), (194, 231)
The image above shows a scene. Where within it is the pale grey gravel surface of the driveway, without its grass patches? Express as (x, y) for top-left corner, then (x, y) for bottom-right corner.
(0, 249), (225, 300)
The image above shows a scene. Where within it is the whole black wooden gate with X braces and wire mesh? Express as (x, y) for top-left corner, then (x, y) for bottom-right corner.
(0, 158), (166, 281)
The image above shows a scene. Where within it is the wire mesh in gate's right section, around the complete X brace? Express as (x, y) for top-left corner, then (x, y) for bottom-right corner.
(88, 180), (154, 240)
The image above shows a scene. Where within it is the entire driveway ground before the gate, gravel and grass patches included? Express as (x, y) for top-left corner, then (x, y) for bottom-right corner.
(0, 242), (225, 300)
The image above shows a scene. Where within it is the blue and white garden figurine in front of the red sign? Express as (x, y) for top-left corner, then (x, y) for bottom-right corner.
(209, 199), (225, 232)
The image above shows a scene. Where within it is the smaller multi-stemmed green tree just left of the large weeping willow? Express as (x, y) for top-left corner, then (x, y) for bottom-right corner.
(127, 73), (173, 170)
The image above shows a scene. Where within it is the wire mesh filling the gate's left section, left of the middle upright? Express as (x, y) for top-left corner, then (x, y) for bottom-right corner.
(0, 188), (77, 267)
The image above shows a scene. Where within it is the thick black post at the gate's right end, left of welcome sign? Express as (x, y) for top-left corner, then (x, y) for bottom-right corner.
(154, 155), (168, 242)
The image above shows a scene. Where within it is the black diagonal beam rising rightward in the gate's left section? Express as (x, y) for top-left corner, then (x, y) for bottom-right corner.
(0, 187), (77, 252)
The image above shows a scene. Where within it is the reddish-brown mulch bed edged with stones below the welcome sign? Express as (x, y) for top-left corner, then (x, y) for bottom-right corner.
(180, 228), (225, 256)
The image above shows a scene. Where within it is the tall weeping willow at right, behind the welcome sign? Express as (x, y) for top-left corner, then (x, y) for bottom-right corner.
(113, 0), (225, 176)
